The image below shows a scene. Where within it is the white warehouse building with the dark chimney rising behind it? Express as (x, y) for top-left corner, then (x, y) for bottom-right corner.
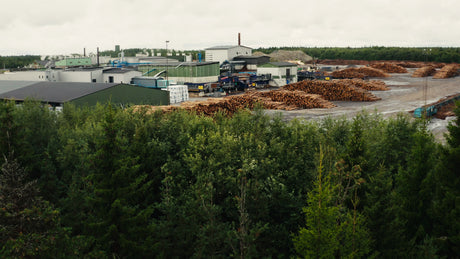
(205, 45), (252, 64)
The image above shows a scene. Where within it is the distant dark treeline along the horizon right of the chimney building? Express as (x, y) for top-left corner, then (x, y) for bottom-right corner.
(253, 47), (460, 63)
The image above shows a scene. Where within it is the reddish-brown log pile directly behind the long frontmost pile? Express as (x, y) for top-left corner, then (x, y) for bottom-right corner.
(283, 80), (380, 102)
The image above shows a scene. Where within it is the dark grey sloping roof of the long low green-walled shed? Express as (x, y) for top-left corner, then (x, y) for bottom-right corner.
(0, 82), (117, 103)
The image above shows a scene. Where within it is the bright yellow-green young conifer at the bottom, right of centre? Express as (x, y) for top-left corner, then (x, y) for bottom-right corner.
(293, 147), (371, 258)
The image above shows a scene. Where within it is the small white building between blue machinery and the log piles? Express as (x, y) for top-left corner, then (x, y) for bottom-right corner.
(257, 62), (297, 87)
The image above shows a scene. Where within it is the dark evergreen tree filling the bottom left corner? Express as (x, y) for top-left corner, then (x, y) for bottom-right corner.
(0, 159), (83, 258)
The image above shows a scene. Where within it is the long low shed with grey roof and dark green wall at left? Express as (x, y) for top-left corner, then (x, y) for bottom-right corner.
(0, 81), (169, 107)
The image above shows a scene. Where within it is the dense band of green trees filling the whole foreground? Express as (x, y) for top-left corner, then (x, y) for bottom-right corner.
(0, 102), (460, 258)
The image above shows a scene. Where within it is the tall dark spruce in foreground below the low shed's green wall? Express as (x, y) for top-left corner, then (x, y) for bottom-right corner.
(83, 105), (152, 257)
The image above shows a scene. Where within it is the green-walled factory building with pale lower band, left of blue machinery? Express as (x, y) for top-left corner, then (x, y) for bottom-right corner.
(138, 62), (220, 84)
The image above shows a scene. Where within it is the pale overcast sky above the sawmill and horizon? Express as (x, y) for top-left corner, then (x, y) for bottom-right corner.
(0, 0), (460, 55)
